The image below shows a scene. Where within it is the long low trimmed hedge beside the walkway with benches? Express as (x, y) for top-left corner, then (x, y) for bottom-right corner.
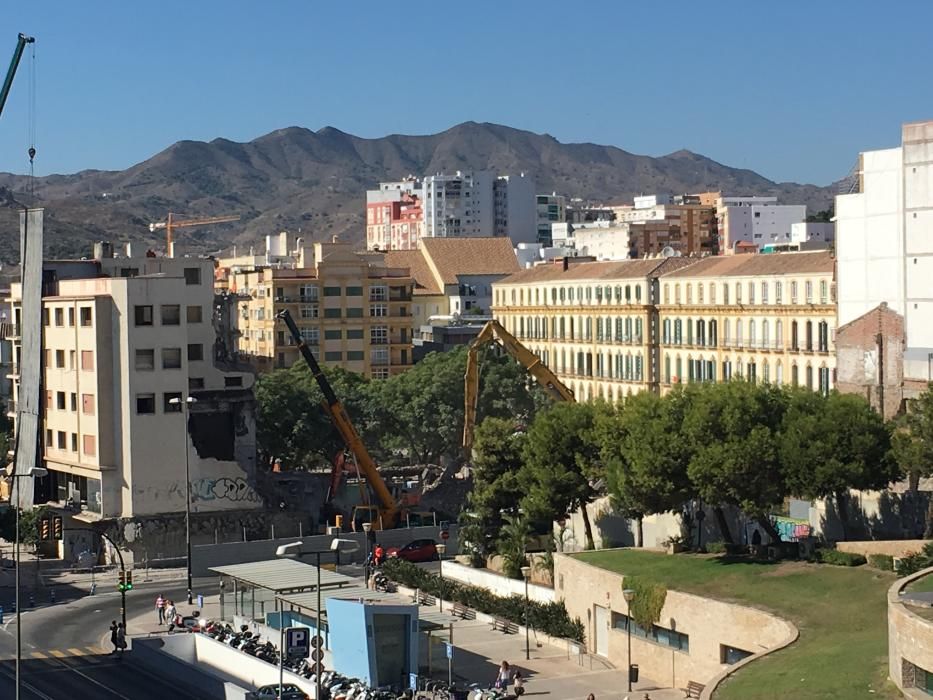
(383, 558), (585, 643)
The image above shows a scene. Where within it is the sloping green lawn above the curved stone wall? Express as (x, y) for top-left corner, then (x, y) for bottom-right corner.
(576, 549), (900, 700)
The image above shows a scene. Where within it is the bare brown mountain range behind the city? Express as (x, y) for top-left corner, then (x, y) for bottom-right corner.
(0, 122), (835, 263)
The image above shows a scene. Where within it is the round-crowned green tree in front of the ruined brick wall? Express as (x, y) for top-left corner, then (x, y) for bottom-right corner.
(780, 389), (898, 539)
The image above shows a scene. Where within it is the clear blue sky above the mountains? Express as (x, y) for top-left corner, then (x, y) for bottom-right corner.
(0, 0), (933, 184)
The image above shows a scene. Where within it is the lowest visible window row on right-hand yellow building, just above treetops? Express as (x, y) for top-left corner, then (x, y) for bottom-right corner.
(663, 355), (833, 395)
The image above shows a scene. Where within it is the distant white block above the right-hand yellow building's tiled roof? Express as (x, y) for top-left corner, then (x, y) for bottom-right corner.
(716, 197), (807, 255)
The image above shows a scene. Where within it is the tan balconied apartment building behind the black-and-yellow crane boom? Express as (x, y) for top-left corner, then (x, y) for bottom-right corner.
(215, 241), (412, 379)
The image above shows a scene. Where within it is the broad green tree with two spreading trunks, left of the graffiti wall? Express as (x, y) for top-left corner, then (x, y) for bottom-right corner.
(683, 380), (787, 543)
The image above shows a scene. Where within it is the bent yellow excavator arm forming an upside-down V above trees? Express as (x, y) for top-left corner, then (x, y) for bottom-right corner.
(463, 319), (575, 450)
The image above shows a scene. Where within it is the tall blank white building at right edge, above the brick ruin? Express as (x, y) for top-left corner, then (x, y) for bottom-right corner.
(836, 121), (933, 380)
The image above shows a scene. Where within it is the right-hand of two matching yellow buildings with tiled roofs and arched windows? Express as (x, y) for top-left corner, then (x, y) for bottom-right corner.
(659, 251), (836, 393)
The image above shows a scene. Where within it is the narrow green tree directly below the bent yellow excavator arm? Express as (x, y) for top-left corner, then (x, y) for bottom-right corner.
(461, 418), (526, 558)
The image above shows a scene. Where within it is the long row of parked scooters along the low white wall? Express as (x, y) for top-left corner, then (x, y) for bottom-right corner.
(201, 622), (405, 700)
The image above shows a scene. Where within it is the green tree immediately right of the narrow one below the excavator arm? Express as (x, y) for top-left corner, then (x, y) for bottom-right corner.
(521, 402), (609, 549)
